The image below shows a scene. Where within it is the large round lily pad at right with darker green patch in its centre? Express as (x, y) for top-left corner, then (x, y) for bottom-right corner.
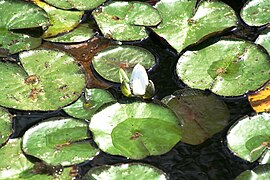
(176, 39), (270, 96)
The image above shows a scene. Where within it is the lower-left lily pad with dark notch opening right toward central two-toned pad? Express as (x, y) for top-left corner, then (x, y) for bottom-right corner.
(22, 118), (98, 166)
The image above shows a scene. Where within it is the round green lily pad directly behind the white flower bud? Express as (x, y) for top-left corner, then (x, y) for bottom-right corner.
(92, 45), (155, 83)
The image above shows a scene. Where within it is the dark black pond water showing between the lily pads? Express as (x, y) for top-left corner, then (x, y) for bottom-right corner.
(5, 0), (266, 180)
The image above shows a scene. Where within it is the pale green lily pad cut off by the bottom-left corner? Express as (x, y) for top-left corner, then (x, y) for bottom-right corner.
(0, 139), (34, 179)
